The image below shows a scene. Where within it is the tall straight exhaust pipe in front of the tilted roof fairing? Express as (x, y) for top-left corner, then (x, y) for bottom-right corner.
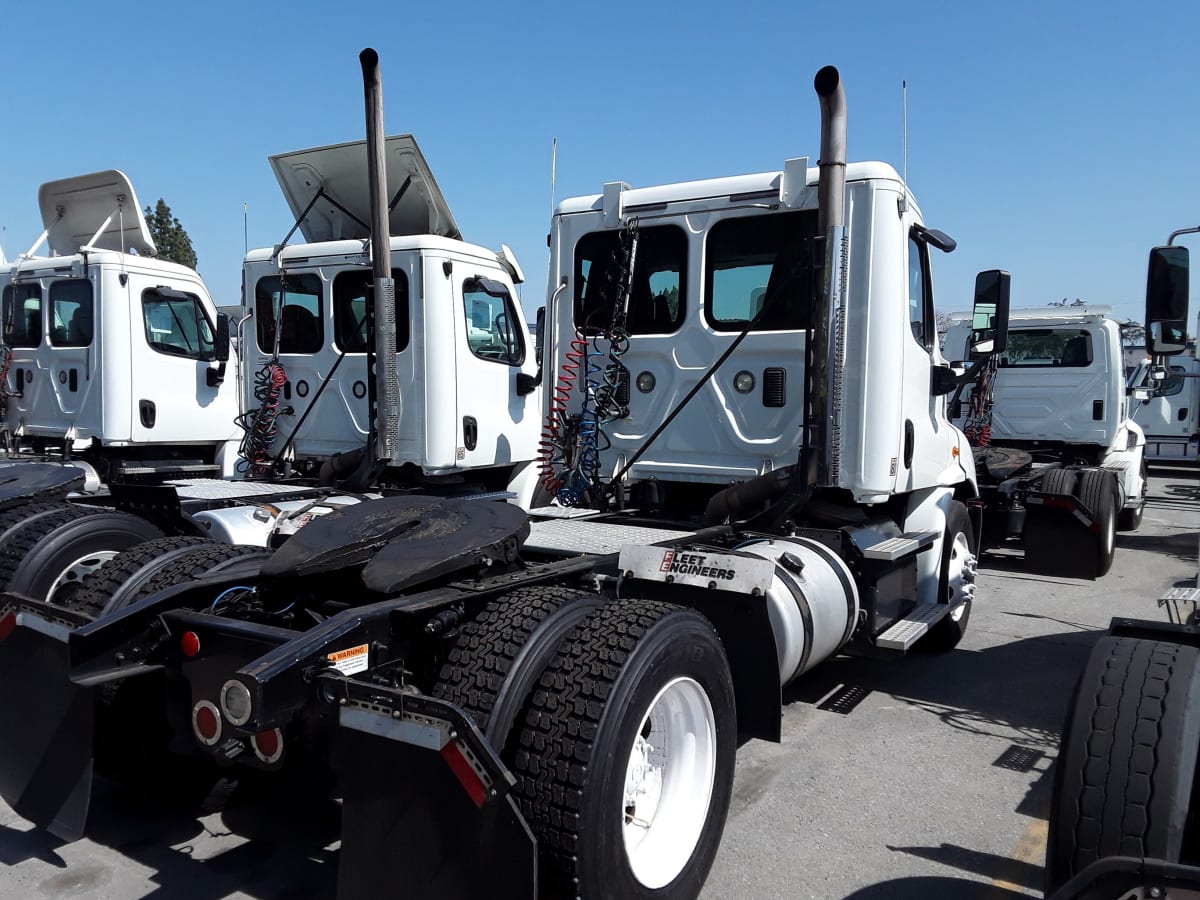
(359, 47), (400, 472)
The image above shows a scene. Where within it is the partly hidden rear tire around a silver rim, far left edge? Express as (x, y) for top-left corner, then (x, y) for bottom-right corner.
(0, 504), (162, 606)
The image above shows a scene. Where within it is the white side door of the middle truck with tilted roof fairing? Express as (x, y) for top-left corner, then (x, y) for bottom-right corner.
(451, 271), (540, 468)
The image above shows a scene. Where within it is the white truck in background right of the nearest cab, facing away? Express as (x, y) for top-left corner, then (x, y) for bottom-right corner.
(944, 307), (1146, 578)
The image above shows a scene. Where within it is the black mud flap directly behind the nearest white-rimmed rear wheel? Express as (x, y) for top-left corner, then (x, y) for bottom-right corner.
(336, 681), (538, 900)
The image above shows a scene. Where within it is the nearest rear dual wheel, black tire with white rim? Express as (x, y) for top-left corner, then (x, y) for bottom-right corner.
(514, 601), (737, 899)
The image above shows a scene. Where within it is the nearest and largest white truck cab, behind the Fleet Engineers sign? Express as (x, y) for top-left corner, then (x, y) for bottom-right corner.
(542, 158), (976, 601)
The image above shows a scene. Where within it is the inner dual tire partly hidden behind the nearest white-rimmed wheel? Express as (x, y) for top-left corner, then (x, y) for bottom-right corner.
(432, 586), (604, 758)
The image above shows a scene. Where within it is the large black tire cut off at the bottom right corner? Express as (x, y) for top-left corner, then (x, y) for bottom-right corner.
(1045, 636), (1200, 896)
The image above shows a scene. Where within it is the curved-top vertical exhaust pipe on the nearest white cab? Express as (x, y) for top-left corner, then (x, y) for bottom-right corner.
(802, 66), (846, 487)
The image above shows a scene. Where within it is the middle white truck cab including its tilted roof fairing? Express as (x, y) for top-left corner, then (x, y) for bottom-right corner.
(238, 136), (540, 505)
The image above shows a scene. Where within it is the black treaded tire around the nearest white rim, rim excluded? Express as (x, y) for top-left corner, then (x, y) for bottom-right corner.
(512, 600), (737, 900)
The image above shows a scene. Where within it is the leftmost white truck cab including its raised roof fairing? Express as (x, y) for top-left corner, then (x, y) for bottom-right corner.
(0, 170), (238, 480)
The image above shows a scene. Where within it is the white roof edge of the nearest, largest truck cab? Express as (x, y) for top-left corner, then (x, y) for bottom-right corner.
(554, 157), (913, 215)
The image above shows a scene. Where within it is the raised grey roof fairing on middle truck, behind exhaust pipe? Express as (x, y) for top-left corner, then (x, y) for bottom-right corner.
(270, 134), (462, 244)
